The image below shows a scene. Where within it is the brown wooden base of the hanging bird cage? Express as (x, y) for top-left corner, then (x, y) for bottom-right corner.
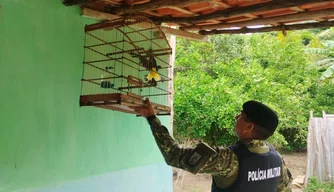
(80, 93), (171, 115)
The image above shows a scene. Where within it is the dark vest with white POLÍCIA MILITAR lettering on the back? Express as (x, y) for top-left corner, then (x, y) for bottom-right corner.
(211, 143), (282, 192)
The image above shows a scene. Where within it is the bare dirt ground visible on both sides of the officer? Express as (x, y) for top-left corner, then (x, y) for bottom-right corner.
(174, 153), (307, 192)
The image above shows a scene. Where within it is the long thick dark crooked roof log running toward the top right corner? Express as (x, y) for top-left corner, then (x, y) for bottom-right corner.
(153, 0), (331, 23)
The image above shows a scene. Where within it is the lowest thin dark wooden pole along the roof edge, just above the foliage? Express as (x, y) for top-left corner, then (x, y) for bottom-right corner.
(200, 21), (334, 35)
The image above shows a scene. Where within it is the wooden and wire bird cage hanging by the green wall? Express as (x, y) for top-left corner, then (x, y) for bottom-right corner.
(80, 16), (172, 115)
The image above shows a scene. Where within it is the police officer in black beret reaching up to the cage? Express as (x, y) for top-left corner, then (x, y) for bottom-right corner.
(132, 99), (292, 192)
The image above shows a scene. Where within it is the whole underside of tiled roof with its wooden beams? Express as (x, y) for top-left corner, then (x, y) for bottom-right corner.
(63, 0), (334, 37)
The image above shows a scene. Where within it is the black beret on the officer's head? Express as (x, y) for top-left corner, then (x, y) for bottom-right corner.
(242, 100), (278, 133)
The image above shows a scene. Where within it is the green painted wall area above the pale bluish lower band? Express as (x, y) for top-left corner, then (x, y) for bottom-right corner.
(0, 0), (169, 191)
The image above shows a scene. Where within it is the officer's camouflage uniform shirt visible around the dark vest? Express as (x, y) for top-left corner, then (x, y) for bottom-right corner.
(148, 118), (292, 192)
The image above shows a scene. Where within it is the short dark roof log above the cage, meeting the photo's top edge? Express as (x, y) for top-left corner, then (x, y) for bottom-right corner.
(110, 0), (210, 15)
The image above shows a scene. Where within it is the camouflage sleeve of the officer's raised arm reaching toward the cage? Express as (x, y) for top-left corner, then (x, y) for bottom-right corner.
(149, 118), (238, 177)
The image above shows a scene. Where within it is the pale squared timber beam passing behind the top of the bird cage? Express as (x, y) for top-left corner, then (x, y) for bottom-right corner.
(81, 7), (209, 42)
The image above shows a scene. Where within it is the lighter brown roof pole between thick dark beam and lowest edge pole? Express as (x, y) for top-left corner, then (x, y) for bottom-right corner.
(180, 9), (334, 31)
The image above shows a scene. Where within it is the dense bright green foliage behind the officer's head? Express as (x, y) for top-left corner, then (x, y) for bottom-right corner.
(174, 28), (334, 149)
